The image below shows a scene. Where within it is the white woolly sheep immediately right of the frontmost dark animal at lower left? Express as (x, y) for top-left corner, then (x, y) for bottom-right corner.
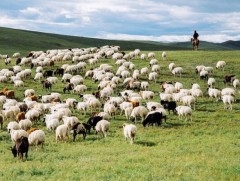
(28, 130), (45, 148)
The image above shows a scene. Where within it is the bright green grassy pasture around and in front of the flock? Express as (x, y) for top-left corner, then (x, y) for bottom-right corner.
(0, 48), (240, 180)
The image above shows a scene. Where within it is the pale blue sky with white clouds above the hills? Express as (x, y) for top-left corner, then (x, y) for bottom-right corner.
(0, 0), (240, 43)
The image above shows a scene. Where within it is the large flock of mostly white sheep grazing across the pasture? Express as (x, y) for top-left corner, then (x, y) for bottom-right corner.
(0, 46), (239, 161)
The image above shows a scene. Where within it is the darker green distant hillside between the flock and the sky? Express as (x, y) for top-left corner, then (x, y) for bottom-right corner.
(0, 27), (240, 54)
